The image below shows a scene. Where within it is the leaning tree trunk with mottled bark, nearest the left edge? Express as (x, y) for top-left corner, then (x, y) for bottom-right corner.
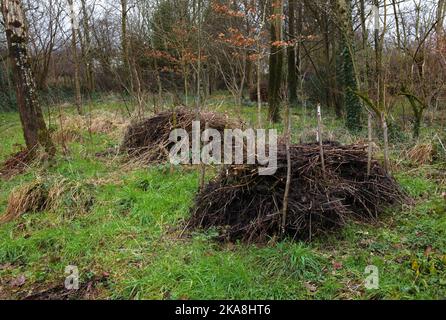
(1, 0), (56, 156)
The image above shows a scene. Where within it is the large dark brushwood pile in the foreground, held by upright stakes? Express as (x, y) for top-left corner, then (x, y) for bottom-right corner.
(188, 142), (407, 242)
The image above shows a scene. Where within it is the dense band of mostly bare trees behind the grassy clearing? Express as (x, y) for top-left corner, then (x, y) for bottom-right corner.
(0, 0), (446, 131)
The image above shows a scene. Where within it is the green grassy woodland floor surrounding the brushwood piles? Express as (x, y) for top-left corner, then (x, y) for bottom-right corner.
(0, 96), (446, 299)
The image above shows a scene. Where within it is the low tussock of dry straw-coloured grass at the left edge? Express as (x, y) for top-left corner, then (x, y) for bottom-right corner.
(0, 177), (94, 224)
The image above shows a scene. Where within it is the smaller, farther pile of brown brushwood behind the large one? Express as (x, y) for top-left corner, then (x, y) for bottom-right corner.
(120, 108), (237, 163)
